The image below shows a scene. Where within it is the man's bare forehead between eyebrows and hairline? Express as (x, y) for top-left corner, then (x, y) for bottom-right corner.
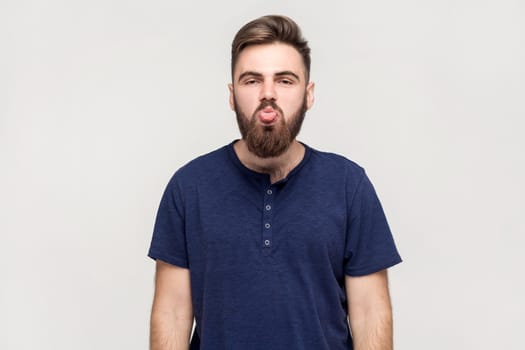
(234, 42), (306, 77)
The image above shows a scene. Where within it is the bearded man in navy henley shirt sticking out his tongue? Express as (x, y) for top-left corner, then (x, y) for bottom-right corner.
(149, 16), (401, 350)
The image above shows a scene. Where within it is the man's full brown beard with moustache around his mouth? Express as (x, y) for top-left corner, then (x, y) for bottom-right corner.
(233, 94), (307, 158)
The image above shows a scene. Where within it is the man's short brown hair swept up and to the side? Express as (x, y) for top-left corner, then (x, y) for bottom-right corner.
(231, 15), (310, 82)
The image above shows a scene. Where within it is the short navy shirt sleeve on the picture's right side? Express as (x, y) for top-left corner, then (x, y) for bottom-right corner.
(344, 172), (402, 276)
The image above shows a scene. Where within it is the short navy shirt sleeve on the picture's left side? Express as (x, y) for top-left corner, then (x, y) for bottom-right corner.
(148, 176), (189, 268)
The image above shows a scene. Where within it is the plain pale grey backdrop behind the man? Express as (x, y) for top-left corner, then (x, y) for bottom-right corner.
(0, 0), (525, 350)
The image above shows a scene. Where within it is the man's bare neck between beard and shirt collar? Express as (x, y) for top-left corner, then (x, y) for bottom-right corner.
(233, 140), (305, 183)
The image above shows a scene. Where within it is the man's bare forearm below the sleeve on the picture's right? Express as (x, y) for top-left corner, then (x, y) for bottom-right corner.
(345, 270), (393, 350)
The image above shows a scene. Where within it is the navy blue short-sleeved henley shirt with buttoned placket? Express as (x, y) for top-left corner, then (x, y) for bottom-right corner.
(149, 143), (401, 350)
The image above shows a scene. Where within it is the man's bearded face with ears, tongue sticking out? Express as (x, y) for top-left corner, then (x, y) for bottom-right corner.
(229, 43), (314, 158)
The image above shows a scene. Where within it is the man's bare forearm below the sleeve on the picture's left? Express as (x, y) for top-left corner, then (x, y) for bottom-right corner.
(150, 260), (193, 350)
